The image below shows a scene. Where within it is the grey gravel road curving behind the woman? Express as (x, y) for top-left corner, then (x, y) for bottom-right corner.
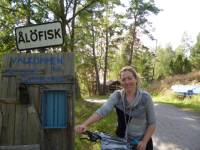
(86, 99), (200, 150)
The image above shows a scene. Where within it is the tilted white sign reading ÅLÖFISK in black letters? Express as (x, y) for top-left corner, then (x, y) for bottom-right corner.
(15, 22), (64, 50)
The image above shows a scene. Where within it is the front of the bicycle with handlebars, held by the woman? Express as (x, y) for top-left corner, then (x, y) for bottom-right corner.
(82, 131), (139, 150)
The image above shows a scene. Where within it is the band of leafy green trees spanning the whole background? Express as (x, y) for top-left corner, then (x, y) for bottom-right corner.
(0, 0), (200, 95)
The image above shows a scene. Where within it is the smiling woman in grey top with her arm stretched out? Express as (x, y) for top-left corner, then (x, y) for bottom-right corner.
(75, 66), (156, 150)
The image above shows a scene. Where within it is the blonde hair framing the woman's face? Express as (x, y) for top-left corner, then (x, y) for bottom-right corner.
(119, 66), (141, 88)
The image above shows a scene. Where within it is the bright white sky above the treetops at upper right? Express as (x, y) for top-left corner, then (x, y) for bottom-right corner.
(149, 0), (200, 49)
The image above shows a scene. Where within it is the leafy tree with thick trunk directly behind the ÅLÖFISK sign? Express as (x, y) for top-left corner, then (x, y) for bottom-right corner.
(0, 0), (103, 52)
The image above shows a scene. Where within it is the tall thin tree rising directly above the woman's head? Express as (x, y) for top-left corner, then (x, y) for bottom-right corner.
(123, 0), (160, 65)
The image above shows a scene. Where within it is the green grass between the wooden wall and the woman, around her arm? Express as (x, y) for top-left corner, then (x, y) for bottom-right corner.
(75, 97), (117, 150)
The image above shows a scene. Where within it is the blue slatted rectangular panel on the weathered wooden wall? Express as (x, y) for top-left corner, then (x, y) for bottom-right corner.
(41, 90), (67, 128)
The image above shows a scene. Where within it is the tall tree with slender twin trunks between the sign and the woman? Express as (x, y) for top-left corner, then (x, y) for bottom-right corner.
(74, 0), (120, 94)
